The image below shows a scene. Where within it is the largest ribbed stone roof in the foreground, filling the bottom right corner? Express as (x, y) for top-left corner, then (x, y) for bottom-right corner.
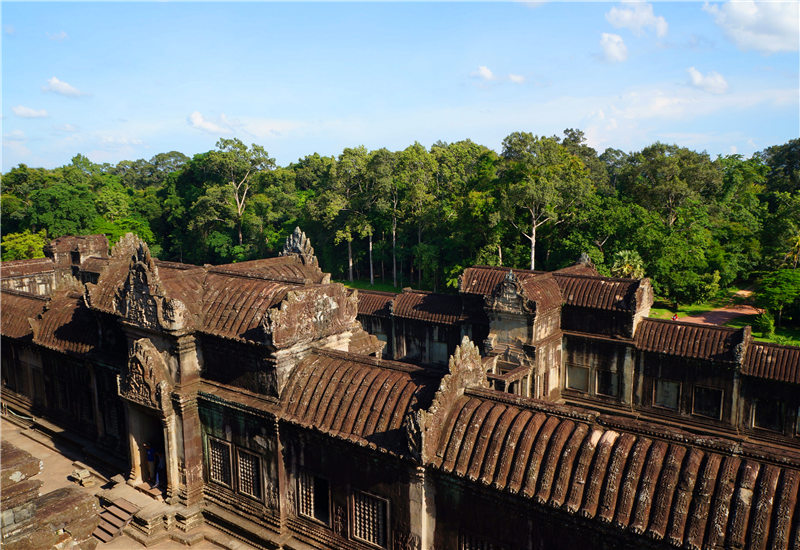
(430, 392), (800, 548)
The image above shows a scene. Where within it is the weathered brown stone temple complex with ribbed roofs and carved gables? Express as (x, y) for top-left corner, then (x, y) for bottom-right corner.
(0, 229), (800, 550)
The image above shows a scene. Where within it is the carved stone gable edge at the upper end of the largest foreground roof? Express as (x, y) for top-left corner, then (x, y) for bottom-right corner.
(403, 336), (489, 462)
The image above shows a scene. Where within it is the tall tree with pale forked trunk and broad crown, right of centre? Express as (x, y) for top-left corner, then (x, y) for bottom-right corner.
(501, 132), (592, 269)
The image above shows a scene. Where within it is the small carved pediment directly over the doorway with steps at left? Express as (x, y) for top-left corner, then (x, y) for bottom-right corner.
(117, 338), (172, 413)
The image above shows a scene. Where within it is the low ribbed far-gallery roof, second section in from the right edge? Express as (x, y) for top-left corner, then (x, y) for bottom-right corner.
(634, 318), (744, 363)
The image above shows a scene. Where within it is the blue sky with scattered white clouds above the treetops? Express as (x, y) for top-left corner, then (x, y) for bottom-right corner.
(1, 1), (800, 172)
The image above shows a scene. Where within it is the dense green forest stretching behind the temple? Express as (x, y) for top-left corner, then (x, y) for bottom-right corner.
(2, 133), (800, 338)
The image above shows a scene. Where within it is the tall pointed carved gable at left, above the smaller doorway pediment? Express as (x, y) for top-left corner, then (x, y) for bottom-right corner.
(111, 233), (188, 330)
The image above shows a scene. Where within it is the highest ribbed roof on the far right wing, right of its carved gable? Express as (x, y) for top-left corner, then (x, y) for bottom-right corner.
(553, 272), (641, 311)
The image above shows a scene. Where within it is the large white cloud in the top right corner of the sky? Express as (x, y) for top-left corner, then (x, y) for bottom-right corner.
(703, 0), (800, 53)
